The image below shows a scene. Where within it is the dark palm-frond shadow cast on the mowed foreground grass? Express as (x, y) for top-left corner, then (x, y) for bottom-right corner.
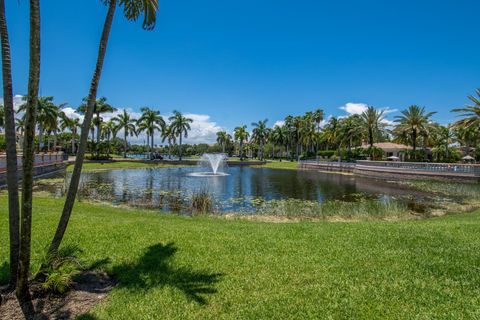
(112, 243), (222, 304)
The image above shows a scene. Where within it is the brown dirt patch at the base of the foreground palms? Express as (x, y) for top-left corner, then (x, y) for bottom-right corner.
(0, 271), (115, 320)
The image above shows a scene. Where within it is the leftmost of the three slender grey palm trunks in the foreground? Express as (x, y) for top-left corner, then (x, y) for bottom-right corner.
(0, 0), (20, 289)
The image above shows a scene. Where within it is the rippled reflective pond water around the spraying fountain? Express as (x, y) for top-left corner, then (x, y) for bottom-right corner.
(71, 166), (436, 212)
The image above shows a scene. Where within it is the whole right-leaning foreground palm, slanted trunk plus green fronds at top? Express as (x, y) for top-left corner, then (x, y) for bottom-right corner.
(50, 0), (158, 253)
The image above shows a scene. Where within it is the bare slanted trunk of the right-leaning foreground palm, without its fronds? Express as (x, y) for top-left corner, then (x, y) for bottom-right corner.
(48, 0), (117, 253)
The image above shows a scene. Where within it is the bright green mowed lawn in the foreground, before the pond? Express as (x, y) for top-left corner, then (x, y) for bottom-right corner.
(0, 196), (480, 319)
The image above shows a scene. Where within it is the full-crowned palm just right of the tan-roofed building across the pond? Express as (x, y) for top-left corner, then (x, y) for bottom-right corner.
(395, 105), (436, 158)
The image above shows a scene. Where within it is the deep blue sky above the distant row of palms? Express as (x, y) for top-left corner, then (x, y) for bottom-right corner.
(3, 0), (480, 141)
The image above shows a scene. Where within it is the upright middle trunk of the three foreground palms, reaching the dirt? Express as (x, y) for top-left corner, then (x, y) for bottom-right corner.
(16, 0), (40, 319)
